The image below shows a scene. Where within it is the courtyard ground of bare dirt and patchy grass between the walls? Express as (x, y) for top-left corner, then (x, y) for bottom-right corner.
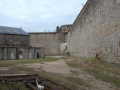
(0, 56), (120, 90)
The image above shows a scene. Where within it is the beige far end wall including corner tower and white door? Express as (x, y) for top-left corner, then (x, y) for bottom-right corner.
(29, 25), (71, 55)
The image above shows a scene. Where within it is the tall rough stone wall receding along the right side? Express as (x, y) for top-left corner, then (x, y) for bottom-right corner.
(67, 0), (120, 64)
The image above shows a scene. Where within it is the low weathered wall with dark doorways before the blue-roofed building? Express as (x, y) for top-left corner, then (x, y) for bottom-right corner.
(0, 47), (44, 60)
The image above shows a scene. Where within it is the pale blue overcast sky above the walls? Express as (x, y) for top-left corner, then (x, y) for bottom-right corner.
(0, 0), (87, 32)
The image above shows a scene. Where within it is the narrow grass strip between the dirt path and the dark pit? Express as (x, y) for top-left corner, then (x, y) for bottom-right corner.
(16, 67), (88, 90)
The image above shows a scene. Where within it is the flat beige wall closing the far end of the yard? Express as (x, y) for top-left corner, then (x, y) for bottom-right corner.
(29, 32), (60, 55)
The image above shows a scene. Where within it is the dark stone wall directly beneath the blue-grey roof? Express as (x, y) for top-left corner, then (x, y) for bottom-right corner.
(0, 34), (29, 46)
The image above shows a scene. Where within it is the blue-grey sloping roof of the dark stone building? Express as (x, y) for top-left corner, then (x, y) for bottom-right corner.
(0, 26), (29, 35)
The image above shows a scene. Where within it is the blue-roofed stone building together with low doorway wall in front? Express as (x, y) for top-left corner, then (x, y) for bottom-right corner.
(0, 26), (44, 60)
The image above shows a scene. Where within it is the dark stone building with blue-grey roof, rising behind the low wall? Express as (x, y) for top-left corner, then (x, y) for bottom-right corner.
(0, 26), (29, 47)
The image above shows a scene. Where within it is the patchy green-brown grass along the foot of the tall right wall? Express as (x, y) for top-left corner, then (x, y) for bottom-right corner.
(65, 57), (120, 87)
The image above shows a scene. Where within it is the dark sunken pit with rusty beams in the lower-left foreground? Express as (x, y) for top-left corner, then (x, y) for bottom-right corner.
(0, 74), (71, 90)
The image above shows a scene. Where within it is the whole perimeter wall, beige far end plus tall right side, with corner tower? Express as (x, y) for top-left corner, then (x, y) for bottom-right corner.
(29, 0), (120, 64)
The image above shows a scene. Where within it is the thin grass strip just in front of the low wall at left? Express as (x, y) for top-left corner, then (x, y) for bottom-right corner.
(0, 57), (59, 66)
